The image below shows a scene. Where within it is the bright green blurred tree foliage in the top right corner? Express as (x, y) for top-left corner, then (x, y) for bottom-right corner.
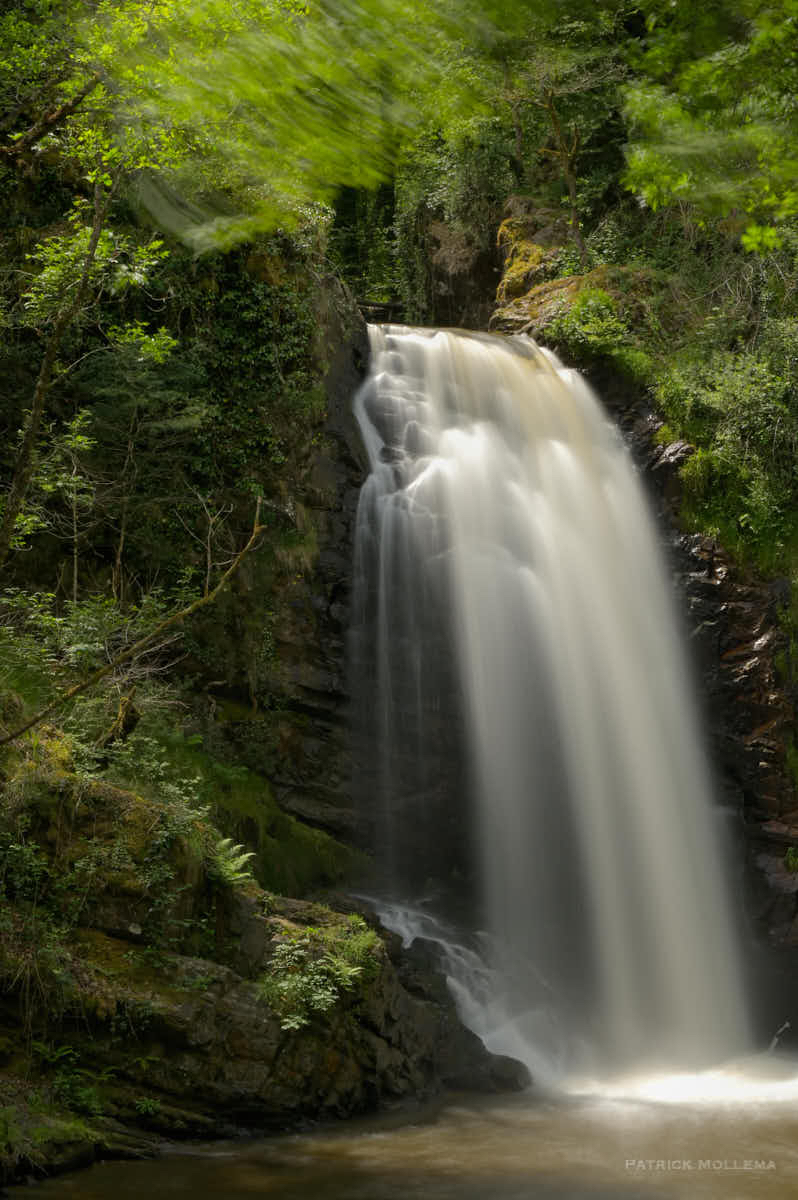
(626, 0), (798, 251)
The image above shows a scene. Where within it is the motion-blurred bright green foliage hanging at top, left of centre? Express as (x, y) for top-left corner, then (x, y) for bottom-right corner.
(105, 0), (542, 246)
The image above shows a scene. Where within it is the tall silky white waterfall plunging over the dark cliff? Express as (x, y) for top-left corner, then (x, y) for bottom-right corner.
(352, 325), (749, 1070)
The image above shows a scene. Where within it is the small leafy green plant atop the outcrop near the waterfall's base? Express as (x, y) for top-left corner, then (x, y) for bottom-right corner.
(259, 917), (378, 1030)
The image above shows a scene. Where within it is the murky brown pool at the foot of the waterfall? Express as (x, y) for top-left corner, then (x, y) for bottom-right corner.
(11, 1064), (798, 1200)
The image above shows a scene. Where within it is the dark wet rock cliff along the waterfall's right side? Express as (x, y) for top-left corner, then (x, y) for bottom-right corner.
(593, 371), (798, 947)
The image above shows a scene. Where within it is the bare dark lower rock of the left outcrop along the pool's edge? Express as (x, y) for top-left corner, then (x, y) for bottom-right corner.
(0, 894), (529, 1183)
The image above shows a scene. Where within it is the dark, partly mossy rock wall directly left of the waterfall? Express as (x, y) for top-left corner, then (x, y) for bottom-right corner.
(196, 278), (368, 844)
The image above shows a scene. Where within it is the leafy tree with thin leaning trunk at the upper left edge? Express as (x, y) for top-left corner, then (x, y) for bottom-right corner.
(0, 0), (187, 570)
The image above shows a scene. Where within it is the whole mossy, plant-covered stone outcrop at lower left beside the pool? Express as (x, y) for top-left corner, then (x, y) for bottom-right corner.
(0, 763), (529, 1182)
